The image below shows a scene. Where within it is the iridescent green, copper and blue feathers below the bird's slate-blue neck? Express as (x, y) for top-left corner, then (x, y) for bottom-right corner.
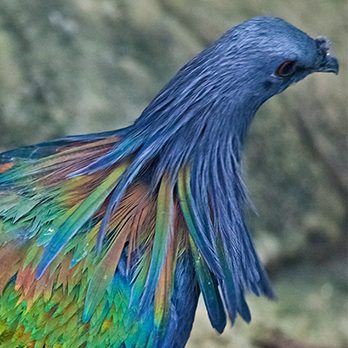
(0, 134), (272, 347)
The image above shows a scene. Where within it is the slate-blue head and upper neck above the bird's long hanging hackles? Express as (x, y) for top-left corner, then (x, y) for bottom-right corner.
(135, 17), (338, 148)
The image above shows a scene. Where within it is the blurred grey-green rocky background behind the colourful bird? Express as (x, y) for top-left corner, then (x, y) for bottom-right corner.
(0, 0), (348, 348)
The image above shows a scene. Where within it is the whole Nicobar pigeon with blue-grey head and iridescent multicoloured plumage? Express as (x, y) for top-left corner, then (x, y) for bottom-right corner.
(0, 16), (339, 348)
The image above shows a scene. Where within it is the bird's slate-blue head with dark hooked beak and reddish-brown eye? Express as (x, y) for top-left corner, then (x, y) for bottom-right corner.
(198, 17), (339, 105)
